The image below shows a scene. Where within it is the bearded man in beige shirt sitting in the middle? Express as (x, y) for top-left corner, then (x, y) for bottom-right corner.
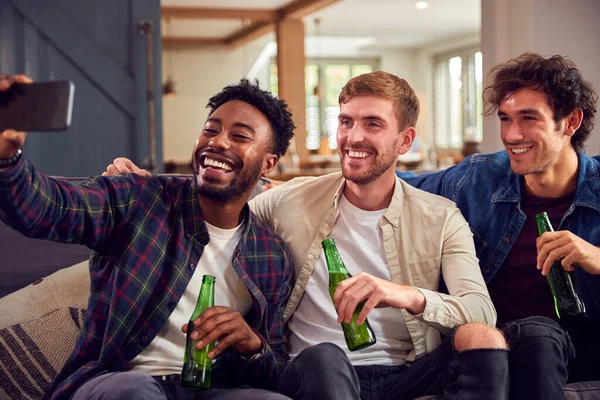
(108, 72), (568, 400)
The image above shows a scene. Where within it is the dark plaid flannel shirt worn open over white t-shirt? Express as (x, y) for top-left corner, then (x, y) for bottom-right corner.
(0, 160), (293, 399)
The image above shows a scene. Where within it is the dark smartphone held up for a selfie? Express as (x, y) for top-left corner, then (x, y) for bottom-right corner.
(0, 81), (75, 132)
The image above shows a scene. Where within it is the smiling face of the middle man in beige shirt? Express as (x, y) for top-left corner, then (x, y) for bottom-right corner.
(337, 96), (414, 185)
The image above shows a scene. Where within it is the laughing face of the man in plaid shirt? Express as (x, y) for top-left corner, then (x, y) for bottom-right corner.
(192, 100), (277, 203)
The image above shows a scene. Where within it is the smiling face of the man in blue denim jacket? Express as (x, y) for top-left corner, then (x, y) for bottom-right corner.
(498, 88), (574, 175)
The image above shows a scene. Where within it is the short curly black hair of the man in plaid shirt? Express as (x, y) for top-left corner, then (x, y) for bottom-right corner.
(206, 78), (296, 157)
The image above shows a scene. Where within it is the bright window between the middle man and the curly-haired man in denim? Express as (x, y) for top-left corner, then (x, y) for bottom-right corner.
(434, 49), (483, 149)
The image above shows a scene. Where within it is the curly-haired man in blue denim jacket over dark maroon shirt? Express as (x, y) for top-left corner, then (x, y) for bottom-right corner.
(399, 53), (600, 382)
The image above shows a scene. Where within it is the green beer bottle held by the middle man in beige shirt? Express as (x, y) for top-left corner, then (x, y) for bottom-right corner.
(321, 238), (377, 351)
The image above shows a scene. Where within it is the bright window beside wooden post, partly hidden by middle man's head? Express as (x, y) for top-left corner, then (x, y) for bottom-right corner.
(270, 59), (378, 150)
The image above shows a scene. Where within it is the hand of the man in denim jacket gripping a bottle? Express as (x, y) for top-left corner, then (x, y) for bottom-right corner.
(536, 231), (600, 276)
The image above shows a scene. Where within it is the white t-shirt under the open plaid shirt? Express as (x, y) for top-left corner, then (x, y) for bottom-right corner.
(129, 219), (252, 375)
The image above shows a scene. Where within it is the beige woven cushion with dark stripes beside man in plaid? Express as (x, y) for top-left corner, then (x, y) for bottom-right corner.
(0, 260), (90, 400)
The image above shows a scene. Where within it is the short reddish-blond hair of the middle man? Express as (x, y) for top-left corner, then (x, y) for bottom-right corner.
(338, 71), (419, 130)
